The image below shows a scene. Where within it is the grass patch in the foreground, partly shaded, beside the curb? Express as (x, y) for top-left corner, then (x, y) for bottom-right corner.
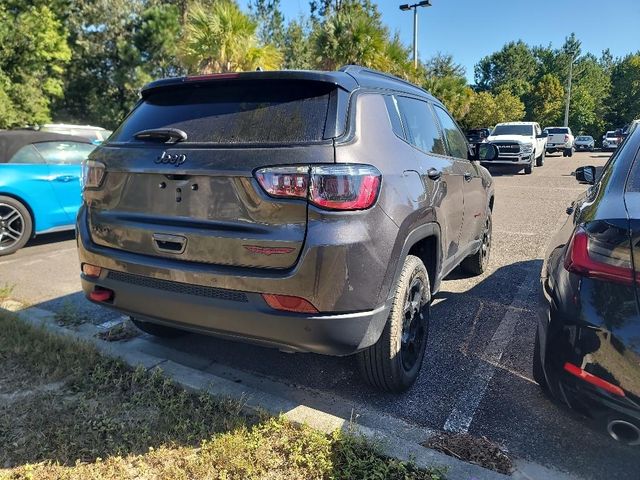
(0, 312), (444, 480)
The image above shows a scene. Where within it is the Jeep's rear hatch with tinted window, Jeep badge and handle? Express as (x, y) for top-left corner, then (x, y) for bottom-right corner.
(85, 75), (350, 269)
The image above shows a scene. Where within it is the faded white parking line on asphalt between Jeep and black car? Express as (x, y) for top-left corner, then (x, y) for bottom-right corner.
(444, 269), (540, 433)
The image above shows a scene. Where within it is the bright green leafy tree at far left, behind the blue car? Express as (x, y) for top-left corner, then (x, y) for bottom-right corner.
(0, 4), (71, 128)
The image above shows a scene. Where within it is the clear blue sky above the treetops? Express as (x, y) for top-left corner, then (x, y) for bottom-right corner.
(239, 0), (640, 83)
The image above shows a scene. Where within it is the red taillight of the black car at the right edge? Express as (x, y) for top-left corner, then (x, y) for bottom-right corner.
(564, 227), (640, 285)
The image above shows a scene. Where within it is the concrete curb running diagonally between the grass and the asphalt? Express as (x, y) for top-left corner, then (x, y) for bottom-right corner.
(0, 300), (570, 480)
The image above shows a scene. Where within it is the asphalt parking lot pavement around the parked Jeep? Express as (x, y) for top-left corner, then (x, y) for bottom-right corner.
(0, 152), (640, 480)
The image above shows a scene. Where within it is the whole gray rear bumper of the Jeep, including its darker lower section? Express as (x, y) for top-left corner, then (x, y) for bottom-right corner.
(77, 207), (395, 356)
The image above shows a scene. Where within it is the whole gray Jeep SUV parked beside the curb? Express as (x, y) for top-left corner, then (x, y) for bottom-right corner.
(77, 66), (493, 391)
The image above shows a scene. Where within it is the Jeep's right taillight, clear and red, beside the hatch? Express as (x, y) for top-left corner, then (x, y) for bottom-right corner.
(255, 165), (382, 210)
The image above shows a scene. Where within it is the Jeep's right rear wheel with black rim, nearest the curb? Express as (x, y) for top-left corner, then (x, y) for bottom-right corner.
(357, 255), (431, 393)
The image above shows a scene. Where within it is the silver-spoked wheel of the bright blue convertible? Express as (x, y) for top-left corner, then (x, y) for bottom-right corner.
(0, 195), (33, 257)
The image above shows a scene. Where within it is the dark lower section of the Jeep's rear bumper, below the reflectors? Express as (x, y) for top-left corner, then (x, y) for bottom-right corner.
(81, 270), (389, 356)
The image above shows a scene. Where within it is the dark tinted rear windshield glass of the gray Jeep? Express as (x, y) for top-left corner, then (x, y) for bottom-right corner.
(110, 80), (335, 144)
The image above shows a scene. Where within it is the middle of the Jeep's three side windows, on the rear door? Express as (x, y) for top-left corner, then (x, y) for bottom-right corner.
(397, 97), (447, 155)
